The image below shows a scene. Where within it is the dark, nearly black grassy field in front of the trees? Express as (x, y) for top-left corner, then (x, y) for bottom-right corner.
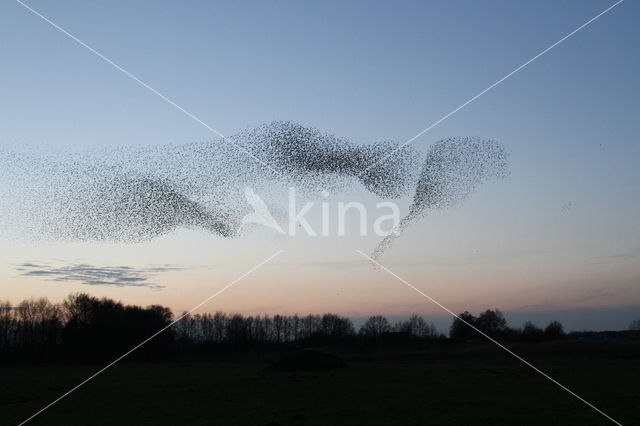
(0, 356), (640, 425)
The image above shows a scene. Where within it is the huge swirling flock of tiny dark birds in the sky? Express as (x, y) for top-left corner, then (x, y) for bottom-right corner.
(0, 122), (508, 257)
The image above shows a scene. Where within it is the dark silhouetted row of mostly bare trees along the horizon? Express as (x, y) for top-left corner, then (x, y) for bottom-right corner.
(0, 293), (576, 362)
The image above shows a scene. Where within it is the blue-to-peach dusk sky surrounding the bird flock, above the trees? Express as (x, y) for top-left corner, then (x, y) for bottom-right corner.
(0, 1), (640, 329)
